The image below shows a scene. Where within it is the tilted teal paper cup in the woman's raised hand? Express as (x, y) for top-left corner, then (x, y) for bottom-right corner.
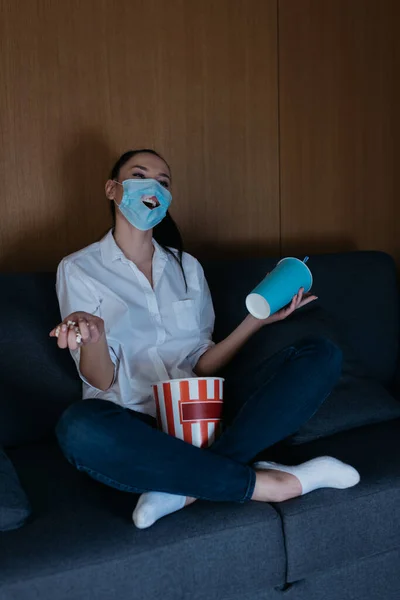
(246, 257), (313, 319)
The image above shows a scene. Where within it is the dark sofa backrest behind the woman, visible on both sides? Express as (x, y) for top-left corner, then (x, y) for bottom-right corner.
(0, 252), (399, 446)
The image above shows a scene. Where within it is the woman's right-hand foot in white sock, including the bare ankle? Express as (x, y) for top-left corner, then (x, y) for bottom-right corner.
(253, 456), (360, 502)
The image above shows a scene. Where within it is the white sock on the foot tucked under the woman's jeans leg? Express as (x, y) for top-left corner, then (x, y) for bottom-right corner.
(132, 492), (186, 529)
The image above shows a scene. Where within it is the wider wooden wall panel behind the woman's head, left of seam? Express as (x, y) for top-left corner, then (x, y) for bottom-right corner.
(0, 0), (279, 270)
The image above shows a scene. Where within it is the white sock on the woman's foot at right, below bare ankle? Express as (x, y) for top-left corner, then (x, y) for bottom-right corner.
(253, 456), (360, 496)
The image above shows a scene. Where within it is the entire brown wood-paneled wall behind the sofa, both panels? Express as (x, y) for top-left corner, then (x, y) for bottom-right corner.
(0, 0), (400, 270)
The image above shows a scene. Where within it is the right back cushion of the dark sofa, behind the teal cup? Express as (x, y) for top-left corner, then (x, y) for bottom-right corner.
(203, 252), (399, 384)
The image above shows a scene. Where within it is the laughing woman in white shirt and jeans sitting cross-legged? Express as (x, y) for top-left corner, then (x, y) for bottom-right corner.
(50, 150), (359, 528)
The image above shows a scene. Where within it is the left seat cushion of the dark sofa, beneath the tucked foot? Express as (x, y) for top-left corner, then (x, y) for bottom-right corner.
(0, 443), (285, 600)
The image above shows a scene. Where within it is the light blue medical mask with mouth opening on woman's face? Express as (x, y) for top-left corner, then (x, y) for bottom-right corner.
(115, 179), (172, 231)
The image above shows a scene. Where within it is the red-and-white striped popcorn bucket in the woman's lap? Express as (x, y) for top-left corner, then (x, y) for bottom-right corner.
(153, 377), (224, 448)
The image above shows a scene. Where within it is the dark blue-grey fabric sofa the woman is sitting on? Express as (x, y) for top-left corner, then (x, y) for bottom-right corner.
(0, 252), (400, 600)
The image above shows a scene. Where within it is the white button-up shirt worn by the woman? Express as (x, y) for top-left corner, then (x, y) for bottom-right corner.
(57, 231), (214, 416)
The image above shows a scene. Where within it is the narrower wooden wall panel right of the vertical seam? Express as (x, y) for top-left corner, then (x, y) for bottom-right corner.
(279, 0), (400, 259)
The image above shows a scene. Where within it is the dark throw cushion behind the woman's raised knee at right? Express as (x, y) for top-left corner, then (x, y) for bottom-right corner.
(217, 302), (400, 444)
